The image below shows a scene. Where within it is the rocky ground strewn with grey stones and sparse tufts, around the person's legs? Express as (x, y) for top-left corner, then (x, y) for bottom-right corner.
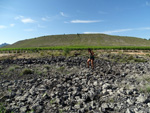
(0, 54), (150, 113)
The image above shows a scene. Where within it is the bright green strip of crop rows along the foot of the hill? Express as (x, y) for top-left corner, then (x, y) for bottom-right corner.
(0, 46), (150, 53)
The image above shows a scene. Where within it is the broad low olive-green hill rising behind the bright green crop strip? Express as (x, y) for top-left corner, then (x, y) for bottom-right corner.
(5, 34), (150, 48)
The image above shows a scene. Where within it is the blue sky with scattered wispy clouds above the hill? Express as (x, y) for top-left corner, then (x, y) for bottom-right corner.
(0, 0), (150, 44)
